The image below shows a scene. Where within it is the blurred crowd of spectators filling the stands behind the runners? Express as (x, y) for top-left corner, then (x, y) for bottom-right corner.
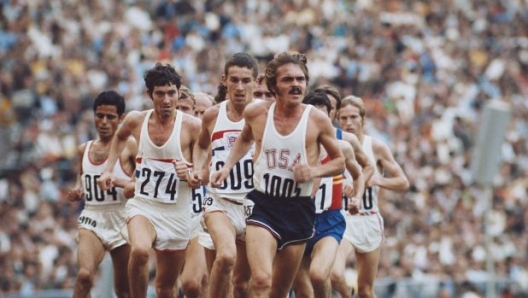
(0, 0), (528, 297)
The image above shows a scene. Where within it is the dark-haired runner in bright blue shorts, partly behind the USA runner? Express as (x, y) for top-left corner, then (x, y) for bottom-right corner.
(293, 92), (365, 298)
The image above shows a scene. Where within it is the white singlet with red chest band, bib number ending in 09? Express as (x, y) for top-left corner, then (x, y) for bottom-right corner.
(207, 101), (254, 200)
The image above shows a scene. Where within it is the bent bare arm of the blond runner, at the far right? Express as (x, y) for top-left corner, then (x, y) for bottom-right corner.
(367, 138), (409, 191)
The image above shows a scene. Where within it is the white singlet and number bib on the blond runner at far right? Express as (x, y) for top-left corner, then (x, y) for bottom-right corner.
(343, 135), (381, 214)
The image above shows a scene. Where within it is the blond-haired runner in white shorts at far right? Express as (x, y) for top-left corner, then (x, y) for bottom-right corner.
(331, 96), (409, 298)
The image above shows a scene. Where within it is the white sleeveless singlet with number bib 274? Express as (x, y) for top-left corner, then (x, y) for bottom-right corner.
(134, 110), (191, 204)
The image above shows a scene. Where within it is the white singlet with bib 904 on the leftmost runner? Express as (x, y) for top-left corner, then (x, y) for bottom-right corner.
(81, 141), (130, 206)
